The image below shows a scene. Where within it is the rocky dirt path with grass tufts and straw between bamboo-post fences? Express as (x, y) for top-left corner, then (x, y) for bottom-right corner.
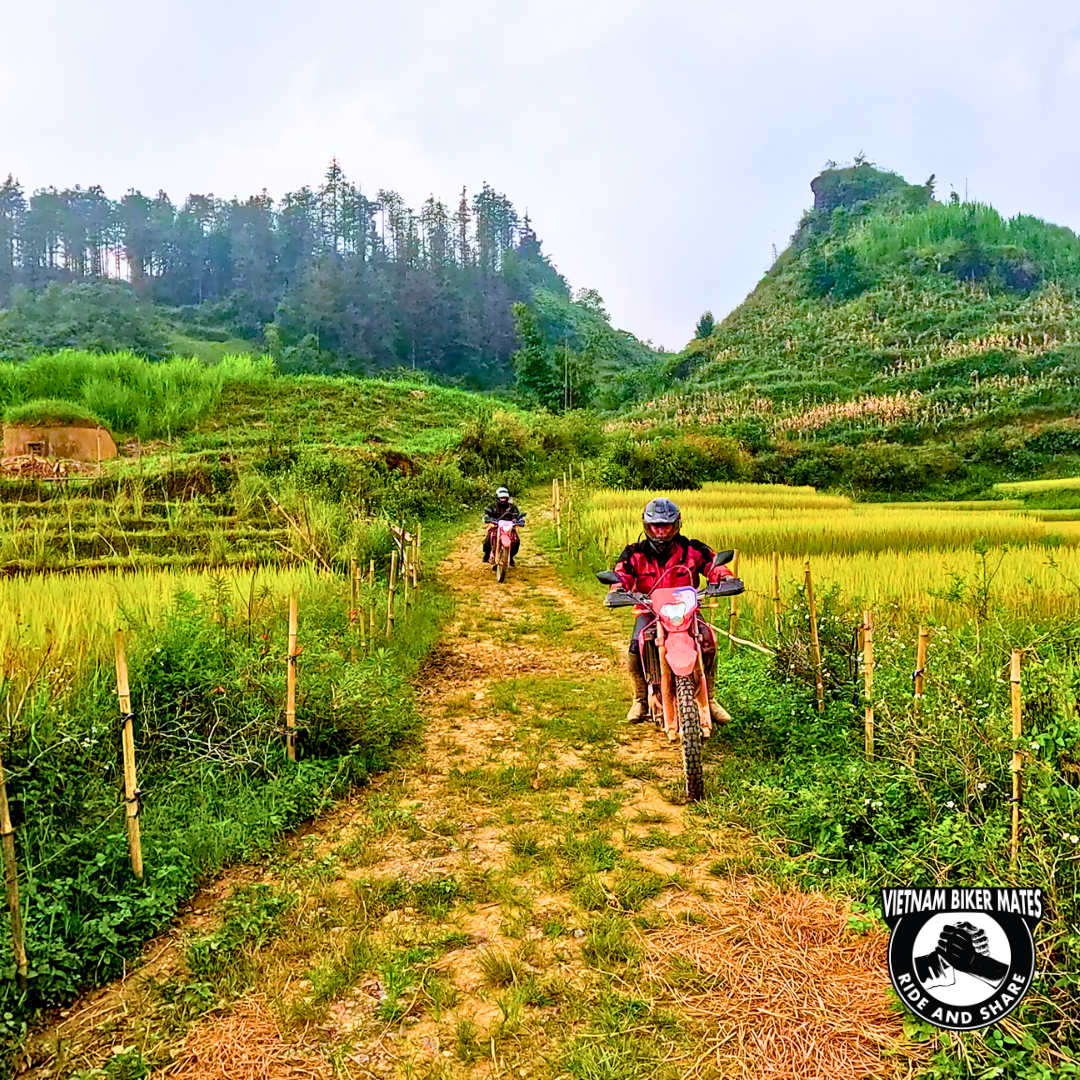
(23, 527), (912, 1080)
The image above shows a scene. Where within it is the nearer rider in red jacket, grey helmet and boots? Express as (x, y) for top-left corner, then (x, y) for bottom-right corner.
(612, 499), (734, 724)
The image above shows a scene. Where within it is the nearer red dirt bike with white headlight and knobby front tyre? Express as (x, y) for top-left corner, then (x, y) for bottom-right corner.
(596, 551), (744, 801)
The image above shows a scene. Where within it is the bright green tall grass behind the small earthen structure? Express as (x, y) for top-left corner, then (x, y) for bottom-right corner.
(0, 351), (272, 438)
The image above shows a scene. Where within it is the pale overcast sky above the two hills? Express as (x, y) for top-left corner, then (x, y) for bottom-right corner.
(0, 0), (1080, 349)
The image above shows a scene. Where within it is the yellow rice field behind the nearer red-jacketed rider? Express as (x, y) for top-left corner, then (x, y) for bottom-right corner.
(582, 484), (1080, 629)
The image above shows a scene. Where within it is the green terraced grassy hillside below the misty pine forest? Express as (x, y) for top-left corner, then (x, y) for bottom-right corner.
(0, 351), (602, 572)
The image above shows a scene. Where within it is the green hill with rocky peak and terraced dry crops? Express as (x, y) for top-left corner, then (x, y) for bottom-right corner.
(639, 160), (1080, 491)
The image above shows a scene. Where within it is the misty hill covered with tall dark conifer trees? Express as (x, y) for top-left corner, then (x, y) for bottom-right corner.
(0, 162), (648, 404)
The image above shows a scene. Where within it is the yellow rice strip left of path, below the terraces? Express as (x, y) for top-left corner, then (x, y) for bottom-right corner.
(0, 567), (314, 677)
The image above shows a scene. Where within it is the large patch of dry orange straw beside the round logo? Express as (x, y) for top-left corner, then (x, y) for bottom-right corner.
(647, 882), (923, 1080)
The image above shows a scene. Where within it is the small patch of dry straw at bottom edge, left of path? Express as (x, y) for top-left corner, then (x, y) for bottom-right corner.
(159, 997), (334, 1080)
